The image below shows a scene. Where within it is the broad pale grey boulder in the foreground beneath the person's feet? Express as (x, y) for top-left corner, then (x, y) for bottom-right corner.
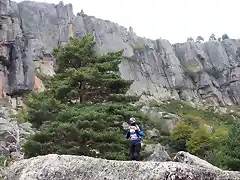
(5, 154), (240, 180)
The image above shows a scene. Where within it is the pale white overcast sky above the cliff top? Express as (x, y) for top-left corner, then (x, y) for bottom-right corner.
(14, 0), (240, 43)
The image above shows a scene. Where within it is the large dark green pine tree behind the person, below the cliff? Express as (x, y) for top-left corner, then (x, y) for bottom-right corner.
(24, 35), (150, 160)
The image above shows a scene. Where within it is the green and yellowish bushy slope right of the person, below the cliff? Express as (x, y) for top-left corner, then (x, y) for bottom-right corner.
(161, 101), (240, 170)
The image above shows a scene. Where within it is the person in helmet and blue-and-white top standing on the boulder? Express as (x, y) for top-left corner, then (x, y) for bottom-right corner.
(126, 117), (144, 161)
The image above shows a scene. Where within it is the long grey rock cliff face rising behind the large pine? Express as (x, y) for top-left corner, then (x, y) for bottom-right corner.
(0, 0), (240, 106)
